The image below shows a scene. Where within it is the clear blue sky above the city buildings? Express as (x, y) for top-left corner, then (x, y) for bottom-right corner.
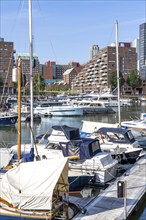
(0, 0), (146, 64)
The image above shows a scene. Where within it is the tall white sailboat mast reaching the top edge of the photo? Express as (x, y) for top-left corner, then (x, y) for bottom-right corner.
(28, 0), (34, 148)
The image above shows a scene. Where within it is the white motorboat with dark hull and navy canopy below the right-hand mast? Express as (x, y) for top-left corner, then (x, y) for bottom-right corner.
(82, 127), (143, 164)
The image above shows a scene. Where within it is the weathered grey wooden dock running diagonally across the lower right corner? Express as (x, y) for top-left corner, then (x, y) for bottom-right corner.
(73, 157), (146, 220)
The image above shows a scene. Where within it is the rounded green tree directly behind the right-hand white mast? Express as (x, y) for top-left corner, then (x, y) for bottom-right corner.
(109, 72), (125, 89)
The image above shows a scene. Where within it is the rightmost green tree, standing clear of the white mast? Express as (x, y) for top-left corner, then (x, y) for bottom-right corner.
(126, 70), (141, 93)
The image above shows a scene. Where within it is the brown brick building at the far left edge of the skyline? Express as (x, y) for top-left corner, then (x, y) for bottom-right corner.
(0, 38), (15, 93)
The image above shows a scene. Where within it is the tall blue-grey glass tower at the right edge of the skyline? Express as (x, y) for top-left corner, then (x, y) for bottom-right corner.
(139, 23), (146, 79)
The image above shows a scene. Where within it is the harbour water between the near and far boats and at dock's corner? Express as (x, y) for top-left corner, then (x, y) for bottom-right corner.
(0, 105), (146, 220)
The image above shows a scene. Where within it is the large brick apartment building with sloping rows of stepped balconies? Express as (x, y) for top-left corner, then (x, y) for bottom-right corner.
(72, 42), (137, 92)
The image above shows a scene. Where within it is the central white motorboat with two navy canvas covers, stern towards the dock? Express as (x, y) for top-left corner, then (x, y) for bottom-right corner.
(38, 125), (117, 184)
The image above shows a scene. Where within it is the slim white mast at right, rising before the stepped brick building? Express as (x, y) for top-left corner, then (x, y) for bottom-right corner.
(116, 21), (121, 126)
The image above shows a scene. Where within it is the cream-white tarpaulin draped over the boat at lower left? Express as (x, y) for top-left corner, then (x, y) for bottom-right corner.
(0, 158), (68, 210)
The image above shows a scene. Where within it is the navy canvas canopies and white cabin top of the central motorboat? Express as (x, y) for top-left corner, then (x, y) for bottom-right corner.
(48, 125), (101, 160)
